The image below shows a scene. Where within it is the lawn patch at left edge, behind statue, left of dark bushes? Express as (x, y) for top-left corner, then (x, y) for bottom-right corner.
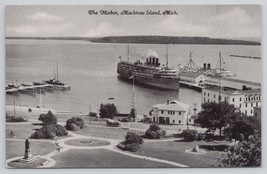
(6, 123), (42, 139)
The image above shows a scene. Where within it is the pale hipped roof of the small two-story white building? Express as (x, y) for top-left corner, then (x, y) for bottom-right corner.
(153, 100), (190, 111)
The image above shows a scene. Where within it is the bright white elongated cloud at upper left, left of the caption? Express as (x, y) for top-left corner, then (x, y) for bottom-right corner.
(27, 12), (65, 22)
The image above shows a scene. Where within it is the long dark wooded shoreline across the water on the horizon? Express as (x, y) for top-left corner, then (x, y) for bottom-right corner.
(6, 36), (261, 46)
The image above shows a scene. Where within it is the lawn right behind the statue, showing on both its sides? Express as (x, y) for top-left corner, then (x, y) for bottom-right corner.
(6, 140), (57, 159)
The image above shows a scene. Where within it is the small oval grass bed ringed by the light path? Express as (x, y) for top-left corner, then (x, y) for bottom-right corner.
(65, 138), (110, 147)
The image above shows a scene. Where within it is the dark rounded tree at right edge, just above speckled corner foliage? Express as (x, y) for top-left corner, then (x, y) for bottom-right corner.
(224, 115), (260, 141)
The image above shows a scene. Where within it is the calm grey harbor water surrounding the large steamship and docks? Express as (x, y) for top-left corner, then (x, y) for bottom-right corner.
(6, 39), (261, 114)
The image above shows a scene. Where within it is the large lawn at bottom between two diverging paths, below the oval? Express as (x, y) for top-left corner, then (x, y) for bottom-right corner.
(53, 149), (174, 168)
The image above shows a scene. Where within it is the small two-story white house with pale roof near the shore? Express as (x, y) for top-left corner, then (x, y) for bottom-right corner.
(152, 100), (194, 124)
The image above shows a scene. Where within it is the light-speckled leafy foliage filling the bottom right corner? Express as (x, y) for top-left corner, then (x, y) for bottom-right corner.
(220, 133), (261, 167)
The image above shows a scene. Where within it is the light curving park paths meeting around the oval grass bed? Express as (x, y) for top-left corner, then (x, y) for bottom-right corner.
(6, 128), (189, 168)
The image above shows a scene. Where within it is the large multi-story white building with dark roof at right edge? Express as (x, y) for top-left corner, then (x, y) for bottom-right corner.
(202, 86), (261, 116)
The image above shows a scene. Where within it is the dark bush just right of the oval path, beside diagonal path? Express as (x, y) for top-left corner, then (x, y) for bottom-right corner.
(117, 132), (143, 152)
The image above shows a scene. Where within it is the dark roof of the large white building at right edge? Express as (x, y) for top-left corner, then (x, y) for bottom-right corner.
(205, 85), (261, 94)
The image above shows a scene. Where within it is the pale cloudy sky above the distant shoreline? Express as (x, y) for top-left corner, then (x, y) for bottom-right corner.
(5, 5), (261, 38)
